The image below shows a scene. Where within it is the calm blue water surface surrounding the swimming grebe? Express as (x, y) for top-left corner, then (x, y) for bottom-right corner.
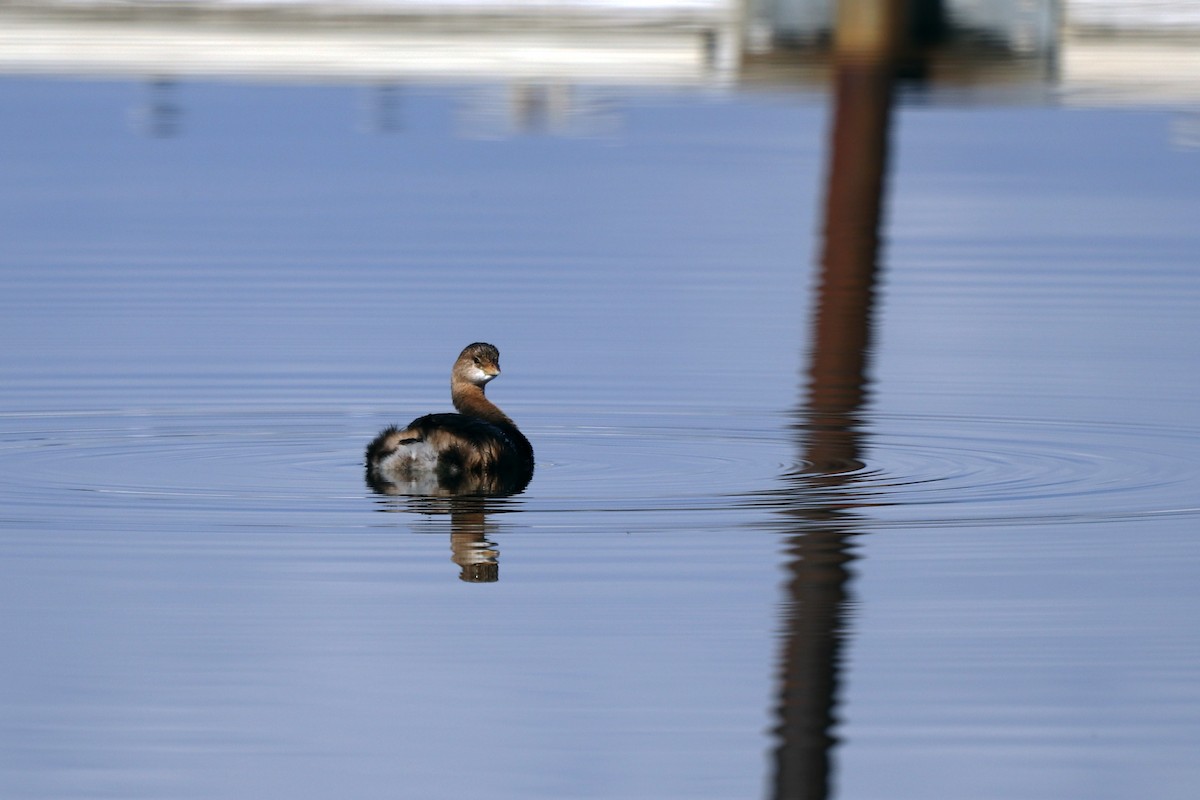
(0, 79), (1200, 800)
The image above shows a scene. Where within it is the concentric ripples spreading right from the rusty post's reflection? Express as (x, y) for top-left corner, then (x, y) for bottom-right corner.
(751, 415), (1200, 527)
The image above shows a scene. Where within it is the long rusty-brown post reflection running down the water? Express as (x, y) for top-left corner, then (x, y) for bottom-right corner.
(772, 0), (904, 800)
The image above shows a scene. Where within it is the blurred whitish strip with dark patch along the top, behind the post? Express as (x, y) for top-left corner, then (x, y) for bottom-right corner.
(0, 0), (1200, 109)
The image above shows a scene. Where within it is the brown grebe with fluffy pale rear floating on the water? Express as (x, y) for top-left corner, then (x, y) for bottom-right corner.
(366, 342), (533, 494)
